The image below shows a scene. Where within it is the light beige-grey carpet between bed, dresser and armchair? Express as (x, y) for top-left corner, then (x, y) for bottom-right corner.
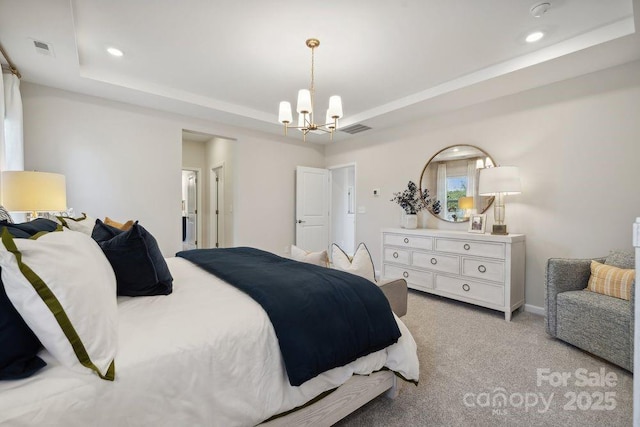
(336, 291), (633, 427)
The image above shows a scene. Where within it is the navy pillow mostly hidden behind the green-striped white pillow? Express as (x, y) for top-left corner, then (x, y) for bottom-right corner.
(0, 224), (48, 380)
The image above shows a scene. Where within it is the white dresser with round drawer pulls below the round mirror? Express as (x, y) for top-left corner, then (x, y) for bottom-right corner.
(382, 228), (525, 321)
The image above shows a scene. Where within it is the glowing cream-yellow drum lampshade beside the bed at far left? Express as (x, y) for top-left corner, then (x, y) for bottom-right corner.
(2, 171), (67, 212)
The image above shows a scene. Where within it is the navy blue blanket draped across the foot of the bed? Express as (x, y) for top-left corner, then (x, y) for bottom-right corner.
(176, 247), (401, 386)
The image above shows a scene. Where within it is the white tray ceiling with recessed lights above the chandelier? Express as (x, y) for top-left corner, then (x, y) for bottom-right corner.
(0, 0), (640, 142)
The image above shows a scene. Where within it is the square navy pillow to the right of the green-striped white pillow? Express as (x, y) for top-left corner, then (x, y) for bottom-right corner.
(91, 219), (173, 297)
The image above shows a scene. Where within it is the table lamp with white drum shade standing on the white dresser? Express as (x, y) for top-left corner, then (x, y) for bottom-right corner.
(478, 166), (521, 235)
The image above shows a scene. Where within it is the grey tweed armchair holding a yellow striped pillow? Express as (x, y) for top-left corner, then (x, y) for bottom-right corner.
(545, 252), (635, 372)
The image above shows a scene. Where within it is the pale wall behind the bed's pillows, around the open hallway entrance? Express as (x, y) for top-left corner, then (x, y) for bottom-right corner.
(21, 82), (324, 256)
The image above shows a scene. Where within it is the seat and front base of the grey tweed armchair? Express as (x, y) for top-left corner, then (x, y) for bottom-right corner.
(557, 291), (633, 370)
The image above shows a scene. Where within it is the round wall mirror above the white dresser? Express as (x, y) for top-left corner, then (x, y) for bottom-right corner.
(420, 145), (495, 222)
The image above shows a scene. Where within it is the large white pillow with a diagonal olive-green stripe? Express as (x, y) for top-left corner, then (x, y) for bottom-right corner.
(0, 228), (118, 380)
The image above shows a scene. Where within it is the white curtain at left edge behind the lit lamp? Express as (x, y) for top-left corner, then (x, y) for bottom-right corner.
(0, 69), (25, 222)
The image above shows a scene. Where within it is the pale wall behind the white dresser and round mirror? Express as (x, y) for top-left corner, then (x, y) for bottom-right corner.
(326, 62), (640, 307)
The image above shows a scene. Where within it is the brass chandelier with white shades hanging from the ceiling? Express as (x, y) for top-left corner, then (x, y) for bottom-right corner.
(278, 39), (342, 141)
